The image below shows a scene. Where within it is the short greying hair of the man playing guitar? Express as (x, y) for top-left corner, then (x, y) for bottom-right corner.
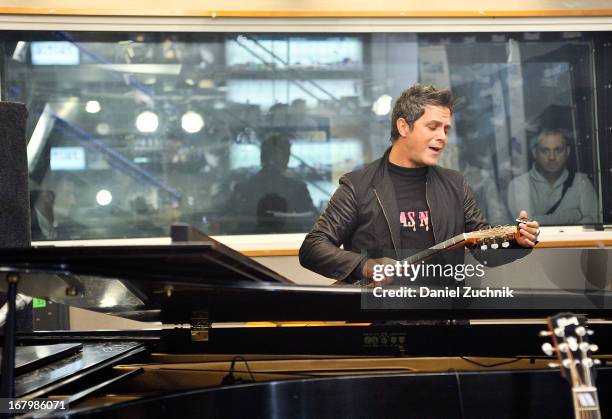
(391, 83), (456, 141)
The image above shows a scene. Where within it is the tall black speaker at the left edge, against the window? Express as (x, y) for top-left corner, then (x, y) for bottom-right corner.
(0, 102), (31, 247)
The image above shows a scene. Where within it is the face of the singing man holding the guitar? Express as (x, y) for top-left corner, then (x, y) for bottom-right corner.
(396, 106), (452, 167)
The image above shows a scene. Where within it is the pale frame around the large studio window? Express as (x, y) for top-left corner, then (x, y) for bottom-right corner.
(0, 14), (612, 256)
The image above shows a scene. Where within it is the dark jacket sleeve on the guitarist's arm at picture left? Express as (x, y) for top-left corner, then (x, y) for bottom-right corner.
(300, 176), (366, 280)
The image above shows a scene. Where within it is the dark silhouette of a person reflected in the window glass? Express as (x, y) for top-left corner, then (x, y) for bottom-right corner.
(227, 134), (318, 234)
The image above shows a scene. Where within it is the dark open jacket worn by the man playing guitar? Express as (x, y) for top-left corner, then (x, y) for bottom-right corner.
(300, 149), (489, 282)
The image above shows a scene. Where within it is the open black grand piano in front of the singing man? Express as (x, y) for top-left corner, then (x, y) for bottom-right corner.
(0, 226), (612, 418)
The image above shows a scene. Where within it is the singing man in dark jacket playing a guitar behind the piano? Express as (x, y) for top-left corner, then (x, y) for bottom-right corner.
(300, 84), (539, 282)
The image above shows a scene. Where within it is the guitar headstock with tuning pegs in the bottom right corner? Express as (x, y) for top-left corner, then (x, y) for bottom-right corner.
(540, 313), (599, 386)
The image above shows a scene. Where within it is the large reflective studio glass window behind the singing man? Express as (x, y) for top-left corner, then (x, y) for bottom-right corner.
(0, 31), (602, 240)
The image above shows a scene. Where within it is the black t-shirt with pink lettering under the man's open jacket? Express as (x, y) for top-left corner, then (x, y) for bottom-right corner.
(387, 161), (435, 258)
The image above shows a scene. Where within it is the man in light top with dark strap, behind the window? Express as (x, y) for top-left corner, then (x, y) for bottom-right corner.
(508, 130), (597, 225)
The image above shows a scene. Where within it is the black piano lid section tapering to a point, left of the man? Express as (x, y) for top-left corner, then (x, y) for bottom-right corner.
(0, 230), (292, 285)
